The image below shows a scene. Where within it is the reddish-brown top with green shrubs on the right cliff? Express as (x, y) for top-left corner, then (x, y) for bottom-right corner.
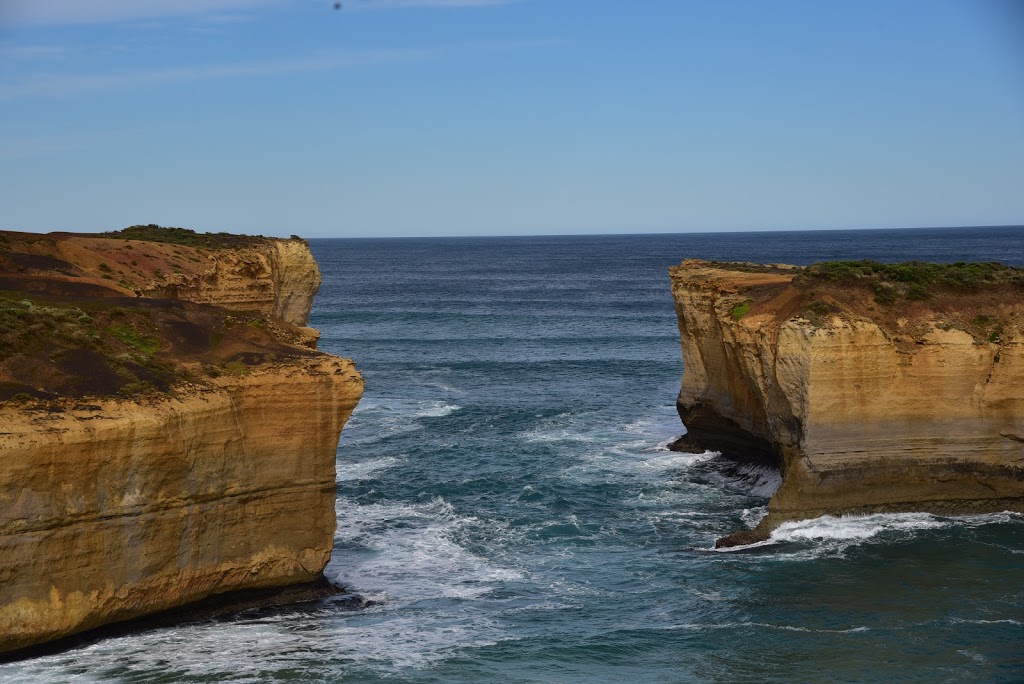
(670, 259), (1024, 342)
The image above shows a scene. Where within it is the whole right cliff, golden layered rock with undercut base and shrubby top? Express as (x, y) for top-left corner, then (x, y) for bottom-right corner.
(670, 260), (1024, 547)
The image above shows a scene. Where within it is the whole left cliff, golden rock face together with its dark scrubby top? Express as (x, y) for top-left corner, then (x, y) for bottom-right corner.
(0, 224), (364, 653)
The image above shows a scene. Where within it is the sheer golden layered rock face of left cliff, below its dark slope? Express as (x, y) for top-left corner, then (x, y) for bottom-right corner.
(0, 354), (362, 652)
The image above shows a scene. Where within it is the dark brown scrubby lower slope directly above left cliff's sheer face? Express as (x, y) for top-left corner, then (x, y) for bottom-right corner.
(0, 291), (318, 401)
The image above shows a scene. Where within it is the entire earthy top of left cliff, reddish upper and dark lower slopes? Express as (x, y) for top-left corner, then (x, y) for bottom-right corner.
(0, 225), (318, 401)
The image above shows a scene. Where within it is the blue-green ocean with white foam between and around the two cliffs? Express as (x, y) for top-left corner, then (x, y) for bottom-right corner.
(0, 228), (1024, 684)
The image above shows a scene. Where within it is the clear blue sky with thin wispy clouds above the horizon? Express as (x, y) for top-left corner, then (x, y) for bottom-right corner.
(0, 0), (1024, 238)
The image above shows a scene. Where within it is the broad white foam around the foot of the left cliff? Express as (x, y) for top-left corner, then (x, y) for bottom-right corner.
(0, 493), (524, 684)
